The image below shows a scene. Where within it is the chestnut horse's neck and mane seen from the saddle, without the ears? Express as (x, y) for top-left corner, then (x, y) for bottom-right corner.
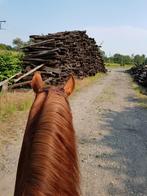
(14, 88), (80, 196)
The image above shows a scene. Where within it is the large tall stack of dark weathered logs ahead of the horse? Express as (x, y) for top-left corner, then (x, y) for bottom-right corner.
(20, 31), (106, 85)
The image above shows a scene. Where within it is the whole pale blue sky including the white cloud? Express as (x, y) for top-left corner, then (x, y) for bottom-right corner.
(0, 0), (147, 56)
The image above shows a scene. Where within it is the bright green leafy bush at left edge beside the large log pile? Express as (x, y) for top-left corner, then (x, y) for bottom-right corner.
(0, 49), (22, 81)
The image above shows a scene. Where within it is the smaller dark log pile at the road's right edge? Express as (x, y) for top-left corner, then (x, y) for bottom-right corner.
(129, 65), (147, 87)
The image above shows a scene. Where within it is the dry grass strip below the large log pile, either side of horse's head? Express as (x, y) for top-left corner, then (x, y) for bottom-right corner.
(0, 73), (105, 121)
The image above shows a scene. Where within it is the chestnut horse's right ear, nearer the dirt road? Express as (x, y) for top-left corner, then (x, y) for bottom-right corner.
(64, 75), (75, 96)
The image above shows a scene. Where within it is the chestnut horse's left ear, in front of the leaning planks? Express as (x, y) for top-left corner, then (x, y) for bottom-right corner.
(31, 72), (44, 93)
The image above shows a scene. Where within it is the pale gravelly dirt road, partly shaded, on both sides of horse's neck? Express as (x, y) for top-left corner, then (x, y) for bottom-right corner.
(0, 69), (147, 196)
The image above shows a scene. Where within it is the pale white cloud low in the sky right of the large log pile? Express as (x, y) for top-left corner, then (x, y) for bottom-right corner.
(87, 26), (147, 55)
